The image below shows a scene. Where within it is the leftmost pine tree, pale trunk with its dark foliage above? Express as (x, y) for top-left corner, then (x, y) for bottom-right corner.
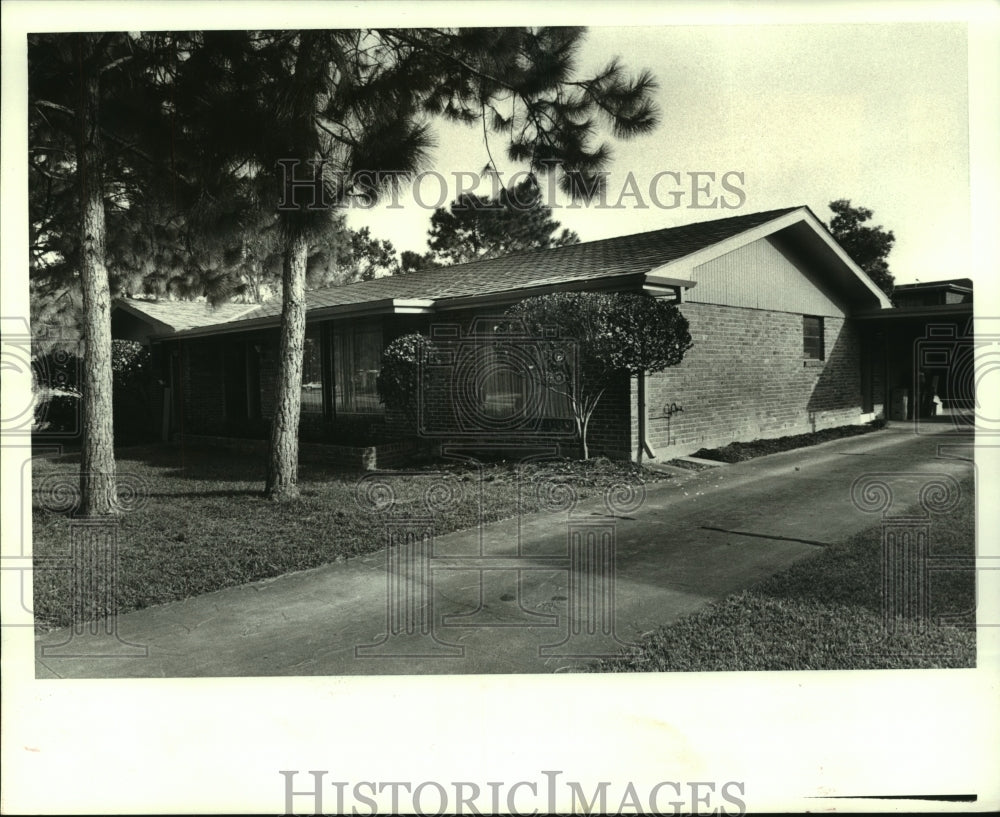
(28, 32), (186, 516)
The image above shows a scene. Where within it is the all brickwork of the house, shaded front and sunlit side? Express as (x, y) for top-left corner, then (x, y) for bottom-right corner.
(168, 303), (883, 464)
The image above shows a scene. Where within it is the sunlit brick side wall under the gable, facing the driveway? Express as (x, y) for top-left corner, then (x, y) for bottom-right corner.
(631, 303), (866, 459)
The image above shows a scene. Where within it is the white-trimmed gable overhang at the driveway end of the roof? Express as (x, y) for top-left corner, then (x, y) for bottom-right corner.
(651, 207), (892, 309)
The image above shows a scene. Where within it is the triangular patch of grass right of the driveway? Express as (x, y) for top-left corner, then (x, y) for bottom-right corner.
(596, 478), (976, 672)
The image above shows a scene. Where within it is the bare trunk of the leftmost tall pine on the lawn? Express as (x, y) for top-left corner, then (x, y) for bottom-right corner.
(77, 34), (117, 516)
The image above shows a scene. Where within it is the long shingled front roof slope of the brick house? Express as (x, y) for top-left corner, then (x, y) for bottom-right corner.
(164, 207), (803, 336)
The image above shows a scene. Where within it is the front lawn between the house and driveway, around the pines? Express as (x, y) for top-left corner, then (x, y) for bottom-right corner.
(32, 446), (666, 630)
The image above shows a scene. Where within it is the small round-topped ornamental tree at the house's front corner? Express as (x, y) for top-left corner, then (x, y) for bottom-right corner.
(507, 292), (692, 462)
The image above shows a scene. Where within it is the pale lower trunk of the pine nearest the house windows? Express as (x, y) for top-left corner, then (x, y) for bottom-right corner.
(265, 230), (309, 499)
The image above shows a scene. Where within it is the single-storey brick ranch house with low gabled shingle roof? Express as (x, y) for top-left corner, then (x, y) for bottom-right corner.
(120, 207), (892, 464)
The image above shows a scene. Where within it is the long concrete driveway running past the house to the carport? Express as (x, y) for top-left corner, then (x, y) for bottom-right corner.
(36, 426), (972, 678)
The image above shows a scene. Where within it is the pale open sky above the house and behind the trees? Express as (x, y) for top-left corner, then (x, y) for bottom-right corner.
(349, 22), (974, 283)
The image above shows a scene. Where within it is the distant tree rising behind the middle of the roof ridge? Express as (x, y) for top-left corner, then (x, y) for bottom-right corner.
(427, 176), (580, 265)
